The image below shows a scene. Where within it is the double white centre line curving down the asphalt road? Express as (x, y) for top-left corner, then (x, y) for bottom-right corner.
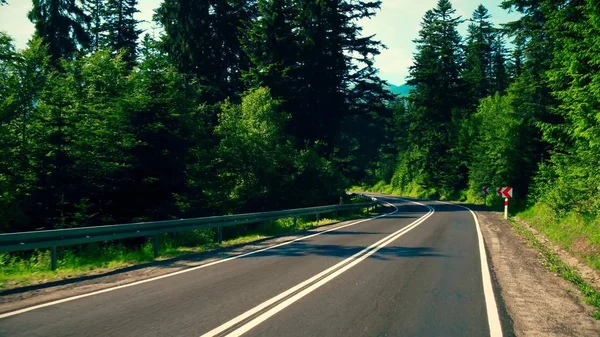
(201, 200), (435, 337)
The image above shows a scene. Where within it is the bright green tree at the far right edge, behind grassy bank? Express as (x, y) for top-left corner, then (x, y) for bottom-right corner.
(537, 0), (600, 216)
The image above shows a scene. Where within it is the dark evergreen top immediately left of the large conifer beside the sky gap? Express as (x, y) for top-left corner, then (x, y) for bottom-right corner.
(155, 0), (254, 104)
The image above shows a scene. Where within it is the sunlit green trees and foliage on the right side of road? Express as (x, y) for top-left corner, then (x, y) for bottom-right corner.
(368, 0), (600, 239)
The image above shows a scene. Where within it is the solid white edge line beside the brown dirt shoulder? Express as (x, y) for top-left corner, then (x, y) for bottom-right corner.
(438, 201), (502, 337)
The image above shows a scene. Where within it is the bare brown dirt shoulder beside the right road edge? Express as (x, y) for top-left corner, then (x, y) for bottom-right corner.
(476, 206), (600, 337)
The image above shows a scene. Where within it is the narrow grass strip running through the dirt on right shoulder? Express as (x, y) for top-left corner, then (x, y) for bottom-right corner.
(510, 218), (600, 319)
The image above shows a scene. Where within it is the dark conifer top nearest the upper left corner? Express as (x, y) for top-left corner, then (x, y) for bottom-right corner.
(28, 0), (90, 66)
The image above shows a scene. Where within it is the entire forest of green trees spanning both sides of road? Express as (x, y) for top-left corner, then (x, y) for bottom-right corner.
(0, 0), (600, 255)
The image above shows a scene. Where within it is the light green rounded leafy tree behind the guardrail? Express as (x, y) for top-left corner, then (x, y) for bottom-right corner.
(215, 88), (295, 210)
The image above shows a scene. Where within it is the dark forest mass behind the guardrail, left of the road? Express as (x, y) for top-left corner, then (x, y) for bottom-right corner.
(0, 0), (392, 232)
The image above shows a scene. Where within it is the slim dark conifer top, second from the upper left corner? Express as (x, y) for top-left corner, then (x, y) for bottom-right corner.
(103, 0), (142, 67)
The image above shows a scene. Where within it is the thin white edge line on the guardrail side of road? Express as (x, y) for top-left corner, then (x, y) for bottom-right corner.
(0, 202), (398, 319)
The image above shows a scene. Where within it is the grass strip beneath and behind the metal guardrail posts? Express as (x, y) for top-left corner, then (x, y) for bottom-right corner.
(0, 200), (372, 289)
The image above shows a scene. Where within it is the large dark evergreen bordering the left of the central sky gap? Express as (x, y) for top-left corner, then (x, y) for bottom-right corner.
(245, 0), (390, 171)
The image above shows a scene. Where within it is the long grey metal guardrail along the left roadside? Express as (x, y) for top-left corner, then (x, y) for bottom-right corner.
(0, 195), (377, 270)
